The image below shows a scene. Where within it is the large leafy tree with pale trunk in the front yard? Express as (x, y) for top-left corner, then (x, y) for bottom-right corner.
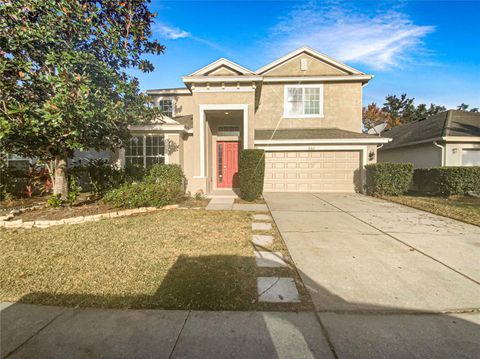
(0, 0), (164, 197)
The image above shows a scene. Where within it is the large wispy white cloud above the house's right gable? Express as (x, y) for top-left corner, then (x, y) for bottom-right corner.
(268, 3), (434, 69)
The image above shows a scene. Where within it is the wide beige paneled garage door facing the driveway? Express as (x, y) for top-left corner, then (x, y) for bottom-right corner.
(264, 151), (360, 192)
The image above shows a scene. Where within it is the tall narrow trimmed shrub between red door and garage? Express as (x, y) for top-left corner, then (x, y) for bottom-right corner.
(239, 149), (265, 201)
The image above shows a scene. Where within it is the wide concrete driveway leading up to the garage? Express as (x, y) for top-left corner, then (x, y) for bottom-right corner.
(265, 193), (480, 358)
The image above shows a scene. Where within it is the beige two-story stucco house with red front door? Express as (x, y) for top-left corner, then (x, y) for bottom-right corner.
(119, 47), (388, 194)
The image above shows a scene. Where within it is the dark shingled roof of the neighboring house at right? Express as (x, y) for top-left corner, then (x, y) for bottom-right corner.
(382, 110), (480, 150)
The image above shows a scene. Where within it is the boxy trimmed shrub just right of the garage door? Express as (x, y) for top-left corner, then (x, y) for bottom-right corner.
(365, 162), (413, 196)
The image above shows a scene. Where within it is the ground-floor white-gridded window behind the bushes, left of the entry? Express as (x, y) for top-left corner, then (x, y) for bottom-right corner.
(125, 135), (165, 169)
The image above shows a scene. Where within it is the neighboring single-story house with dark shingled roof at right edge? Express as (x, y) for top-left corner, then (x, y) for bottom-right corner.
(378, 110), (480, 168)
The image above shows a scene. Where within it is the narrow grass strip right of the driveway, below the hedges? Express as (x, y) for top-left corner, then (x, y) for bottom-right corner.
(384, 196), (480, 226)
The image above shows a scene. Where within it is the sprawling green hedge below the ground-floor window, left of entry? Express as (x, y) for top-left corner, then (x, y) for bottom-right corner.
(103, 164), (185, 208)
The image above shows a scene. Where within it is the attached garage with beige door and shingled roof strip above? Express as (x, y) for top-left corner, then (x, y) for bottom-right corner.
(255, 128), (389, 192)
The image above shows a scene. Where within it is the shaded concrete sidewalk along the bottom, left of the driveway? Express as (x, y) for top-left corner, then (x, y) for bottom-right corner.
(0, 303), (333, 359)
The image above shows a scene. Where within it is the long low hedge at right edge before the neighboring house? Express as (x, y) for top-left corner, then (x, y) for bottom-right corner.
(413, 166), (480, 196)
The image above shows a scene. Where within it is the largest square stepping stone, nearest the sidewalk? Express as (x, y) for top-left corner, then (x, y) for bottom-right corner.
(257, 277), (300, 303)
